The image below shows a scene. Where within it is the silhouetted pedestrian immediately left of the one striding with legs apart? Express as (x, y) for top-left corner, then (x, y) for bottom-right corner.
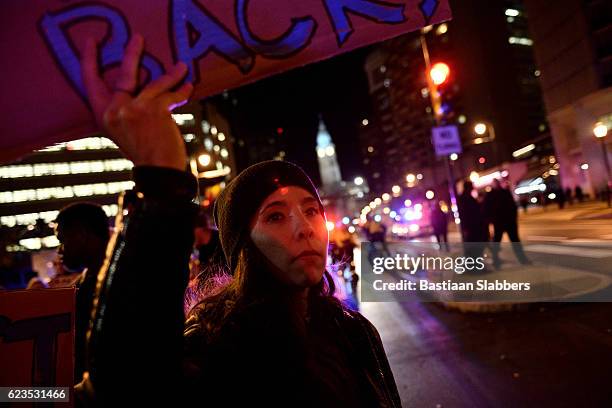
(457, 180), (489, 258)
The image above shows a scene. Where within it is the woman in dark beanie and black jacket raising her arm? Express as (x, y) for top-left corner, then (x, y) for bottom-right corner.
(78, 36), (400, 407)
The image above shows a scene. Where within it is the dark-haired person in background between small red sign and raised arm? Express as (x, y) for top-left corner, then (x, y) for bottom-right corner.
(28, 202), (110, 382)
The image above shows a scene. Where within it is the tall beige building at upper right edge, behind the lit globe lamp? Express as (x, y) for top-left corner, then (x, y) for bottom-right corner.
(525, 0), (612, 194)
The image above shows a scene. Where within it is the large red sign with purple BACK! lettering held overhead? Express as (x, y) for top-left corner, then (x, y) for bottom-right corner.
(0, 0), (451, 161)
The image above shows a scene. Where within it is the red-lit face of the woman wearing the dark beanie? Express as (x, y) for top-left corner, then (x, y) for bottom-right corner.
(251, 186), (328, 288)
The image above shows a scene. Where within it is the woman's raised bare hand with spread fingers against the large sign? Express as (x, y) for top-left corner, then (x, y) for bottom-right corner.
(81, 34), (193, 170)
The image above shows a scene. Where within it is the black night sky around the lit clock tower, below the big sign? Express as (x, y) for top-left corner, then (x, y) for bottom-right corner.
(210, 47), (371, 185)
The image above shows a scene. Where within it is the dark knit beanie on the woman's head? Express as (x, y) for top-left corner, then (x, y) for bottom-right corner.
(214, 160), (323, 272)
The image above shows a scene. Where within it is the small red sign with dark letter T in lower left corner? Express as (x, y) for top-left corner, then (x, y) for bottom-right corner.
(0, 288), (75, 400)
